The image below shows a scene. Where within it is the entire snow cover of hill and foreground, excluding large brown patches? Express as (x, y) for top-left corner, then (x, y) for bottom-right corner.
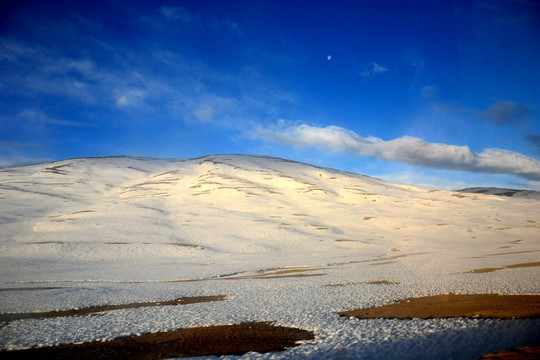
(0, 155), (540, 359)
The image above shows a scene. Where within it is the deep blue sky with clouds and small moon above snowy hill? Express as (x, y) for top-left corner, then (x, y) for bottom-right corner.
(0, 0), (540, 189)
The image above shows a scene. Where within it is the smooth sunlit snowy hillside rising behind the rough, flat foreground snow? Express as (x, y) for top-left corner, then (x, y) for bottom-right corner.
(0, 156), (540, 281)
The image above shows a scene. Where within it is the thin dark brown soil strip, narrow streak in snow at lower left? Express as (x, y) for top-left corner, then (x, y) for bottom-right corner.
(0, 295), (227, 321)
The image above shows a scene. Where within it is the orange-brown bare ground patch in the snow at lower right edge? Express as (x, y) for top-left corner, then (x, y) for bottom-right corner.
(340, 294), (540, 319)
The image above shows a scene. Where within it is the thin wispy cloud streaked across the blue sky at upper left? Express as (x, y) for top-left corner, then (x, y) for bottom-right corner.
(0, 6), (282, 125)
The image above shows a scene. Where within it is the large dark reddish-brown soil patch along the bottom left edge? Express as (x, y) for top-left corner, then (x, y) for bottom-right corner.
(0, 322), (315, 360)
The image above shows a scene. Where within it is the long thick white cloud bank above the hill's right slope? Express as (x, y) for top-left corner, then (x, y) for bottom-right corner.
(255, 124), (540, 181)
